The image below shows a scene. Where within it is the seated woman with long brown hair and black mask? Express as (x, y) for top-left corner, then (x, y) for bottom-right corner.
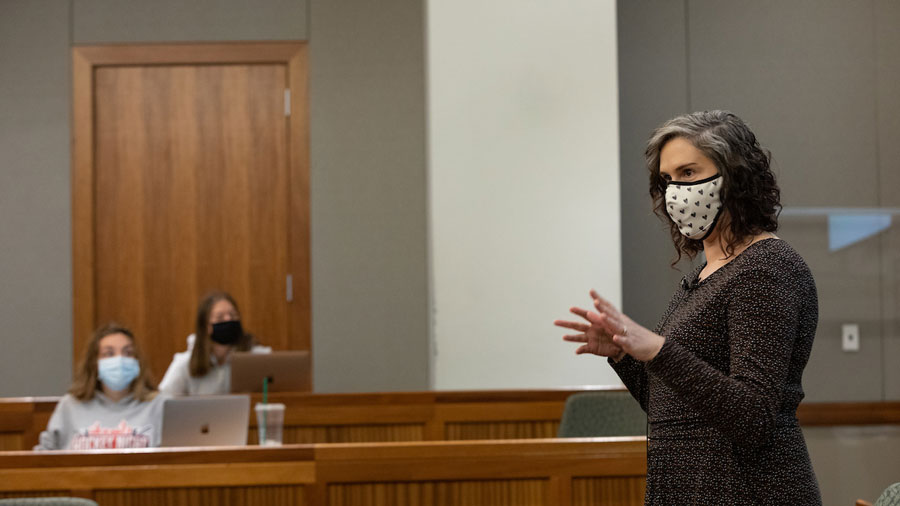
(159, 292), (272, 395)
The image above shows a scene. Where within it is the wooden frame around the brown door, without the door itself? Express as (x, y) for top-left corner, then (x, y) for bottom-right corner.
(71, 42), (312, 373)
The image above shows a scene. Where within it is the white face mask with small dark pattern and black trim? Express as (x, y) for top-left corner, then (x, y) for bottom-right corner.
(666, 174), (722, 241)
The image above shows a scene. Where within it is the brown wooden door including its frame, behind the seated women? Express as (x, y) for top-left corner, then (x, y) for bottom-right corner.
(73, 44), (310, 379)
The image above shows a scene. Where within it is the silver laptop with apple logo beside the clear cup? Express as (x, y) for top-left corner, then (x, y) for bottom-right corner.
(161, 395), (250, 446)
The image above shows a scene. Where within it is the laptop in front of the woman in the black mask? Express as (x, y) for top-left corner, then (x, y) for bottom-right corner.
(231, 351), (311, 392)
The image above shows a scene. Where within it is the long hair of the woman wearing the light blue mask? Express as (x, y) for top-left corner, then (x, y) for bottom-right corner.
(69, 322), (156, 402)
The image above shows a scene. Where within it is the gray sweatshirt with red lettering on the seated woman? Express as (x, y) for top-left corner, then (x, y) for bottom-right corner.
(34, 392), (167, 450)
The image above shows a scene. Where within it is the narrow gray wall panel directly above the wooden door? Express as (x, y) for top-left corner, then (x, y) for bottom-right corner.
(72, 0), (308, 44)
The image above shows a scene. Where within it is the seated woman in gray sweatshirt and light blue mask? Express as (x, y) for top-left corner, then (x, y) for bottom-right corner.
(34, 323), (164, 450)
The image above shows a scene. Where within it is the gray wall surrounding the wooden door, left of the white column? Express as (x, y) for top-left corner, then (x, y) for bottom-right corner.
(0, 0), (428, 397)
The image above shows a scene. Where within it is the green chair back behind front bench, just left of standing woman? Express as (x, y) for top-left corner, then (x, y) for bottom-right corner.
(557, 391), (647, 437)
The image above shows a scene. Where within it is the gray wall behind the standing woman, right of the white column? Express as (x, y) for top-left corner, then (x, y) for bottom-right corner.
(618, 0), (900, 401)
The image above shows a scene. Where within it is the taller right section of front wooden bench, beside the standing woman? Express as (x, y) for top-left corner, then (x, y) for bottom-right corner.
(316, 438), (646, 506)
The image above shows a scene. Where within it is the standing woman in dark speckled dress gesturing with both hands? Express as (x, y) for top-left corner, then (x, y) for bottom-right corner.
(555, 111), (821, 505)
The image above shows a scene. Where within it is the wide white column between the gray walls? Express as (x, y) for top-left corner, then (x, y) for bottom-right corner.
(427, 0), (622, 390)
